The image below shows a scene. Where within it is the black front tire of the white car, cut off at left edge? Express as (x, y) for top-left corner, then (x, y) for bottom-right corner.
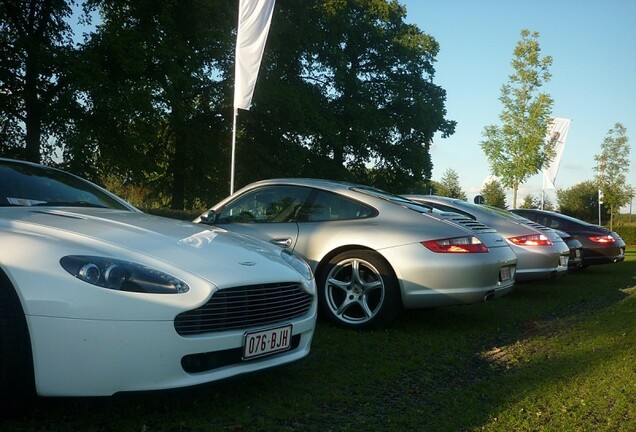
(0, 270), (35, 409)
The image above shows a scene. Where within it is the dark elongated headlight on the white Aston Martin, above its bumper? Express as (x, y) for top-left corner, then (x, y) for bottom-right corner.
(60, 255), (190, 294)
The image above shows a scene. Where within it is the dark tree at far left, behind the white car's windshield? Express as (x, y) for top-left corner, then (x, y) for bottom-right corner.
(0, 0), (74, 162)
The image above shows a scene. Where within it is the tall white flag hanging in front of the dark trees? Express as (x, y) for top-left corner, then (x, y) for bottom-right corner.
(234, 0), (275, 110)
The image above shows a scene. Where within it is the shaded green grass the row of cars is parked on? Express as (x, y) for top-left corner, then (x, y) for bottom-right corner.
(0, 248), (636, 432)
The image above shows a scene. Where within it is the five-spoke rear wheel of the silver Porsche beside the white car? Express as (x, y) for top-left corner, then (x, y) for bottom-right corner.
(318, 250), (401, 329)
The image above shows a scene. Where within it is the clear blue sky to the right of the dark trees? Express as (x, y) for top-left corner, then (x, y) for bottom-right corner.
(400, 0), (636, 210)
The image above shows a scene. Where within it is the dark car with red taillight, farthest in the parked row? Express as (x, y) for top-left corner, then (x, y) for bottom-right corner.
(511, 209), (625, 267)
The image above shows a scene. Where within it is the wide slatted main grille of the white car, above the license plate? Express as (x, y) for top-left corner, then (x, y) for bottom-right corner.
(174, 283), (313, 336)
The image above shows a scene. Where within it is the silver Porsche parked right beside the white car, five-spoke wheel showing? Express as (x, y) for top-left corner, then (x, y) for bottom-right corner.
(195, 179), (517, 328)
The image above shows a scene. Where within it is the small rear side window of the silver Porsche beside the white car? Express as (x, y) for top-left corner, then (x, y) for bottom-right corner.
(299, 191), (376, 222)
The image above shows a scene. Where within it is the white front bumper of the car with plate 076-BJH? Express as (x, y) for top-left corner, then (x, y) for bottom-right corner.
(27, 304), (316, 396)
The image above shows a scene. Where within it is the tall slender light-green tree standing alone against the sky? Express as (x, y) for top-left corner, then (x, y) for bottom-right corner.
(481, 30), (556, 208)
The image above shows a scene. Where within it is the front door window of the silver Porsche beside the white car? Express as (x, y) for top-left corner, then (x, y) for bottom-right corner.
(216, 186), (311, 224)
